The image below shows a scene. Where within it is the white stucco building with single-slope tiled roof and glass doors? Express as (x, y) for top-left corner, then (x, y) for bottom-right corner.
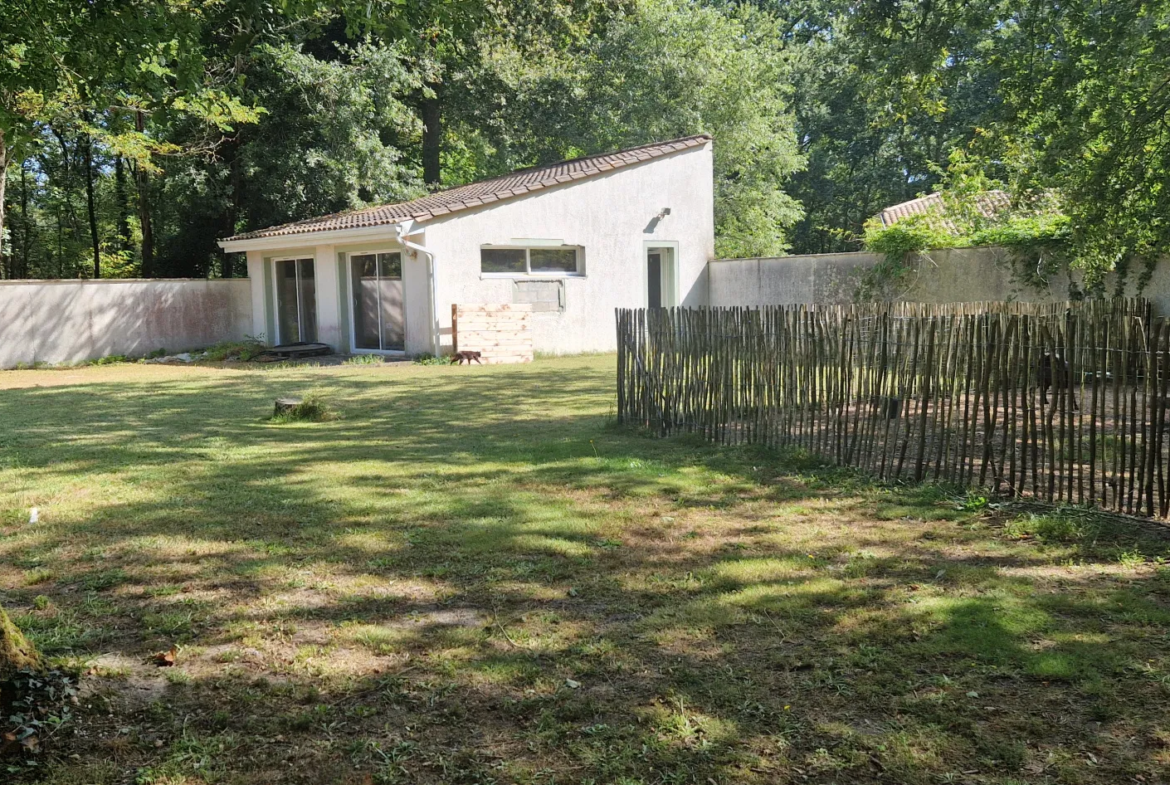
(220, 136), (715, 354)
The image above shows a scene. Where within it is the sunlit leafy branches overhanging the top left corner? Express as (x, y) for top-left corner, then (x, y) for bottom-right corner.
(0, 0), (265, 274)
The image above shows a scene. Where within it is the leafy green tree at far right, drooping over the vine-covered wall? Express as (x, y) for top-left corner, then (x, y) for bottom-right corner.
(837, 0), (1170, 275)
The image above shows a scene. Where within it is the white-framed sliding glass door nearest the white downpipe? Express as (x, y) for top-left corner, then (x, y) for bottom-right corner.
(350, 252), (406, 352)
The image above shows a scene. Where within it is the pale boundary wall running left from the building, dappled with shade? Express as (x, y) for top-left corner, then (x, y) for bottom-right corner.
(0, 278), (252, 369)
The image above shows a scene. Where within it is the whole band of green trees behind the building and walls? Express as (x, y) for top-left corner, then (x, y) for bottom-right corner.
(0, 0), (1170, 283)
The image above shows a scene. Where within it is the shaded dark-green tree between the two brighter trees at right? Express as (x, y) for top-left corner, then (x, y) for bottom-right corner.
(757, 0), (999, 253)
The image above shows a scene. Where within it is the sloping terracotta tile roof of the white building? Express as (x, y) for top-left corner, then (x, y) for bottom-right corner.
(222, 133), (711, 242)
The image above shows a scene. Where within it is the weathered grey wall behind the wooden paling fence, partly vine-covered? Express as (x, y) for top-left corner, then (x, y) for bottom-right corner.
(708, 247), (1170, 316)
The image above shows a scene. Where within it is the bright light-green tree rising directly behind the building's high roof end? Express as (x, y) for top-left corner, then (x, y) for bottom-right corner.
(482, 0), (804, 256)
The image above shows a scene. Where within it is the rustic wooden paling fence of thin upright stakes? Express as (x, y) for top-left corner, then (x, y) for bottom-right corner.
(617, 299), (1170, 518)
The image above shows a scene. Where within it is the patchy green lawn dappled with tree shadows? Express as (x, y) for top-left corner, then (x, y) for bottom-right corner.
(0, 357), (1170, 785)
